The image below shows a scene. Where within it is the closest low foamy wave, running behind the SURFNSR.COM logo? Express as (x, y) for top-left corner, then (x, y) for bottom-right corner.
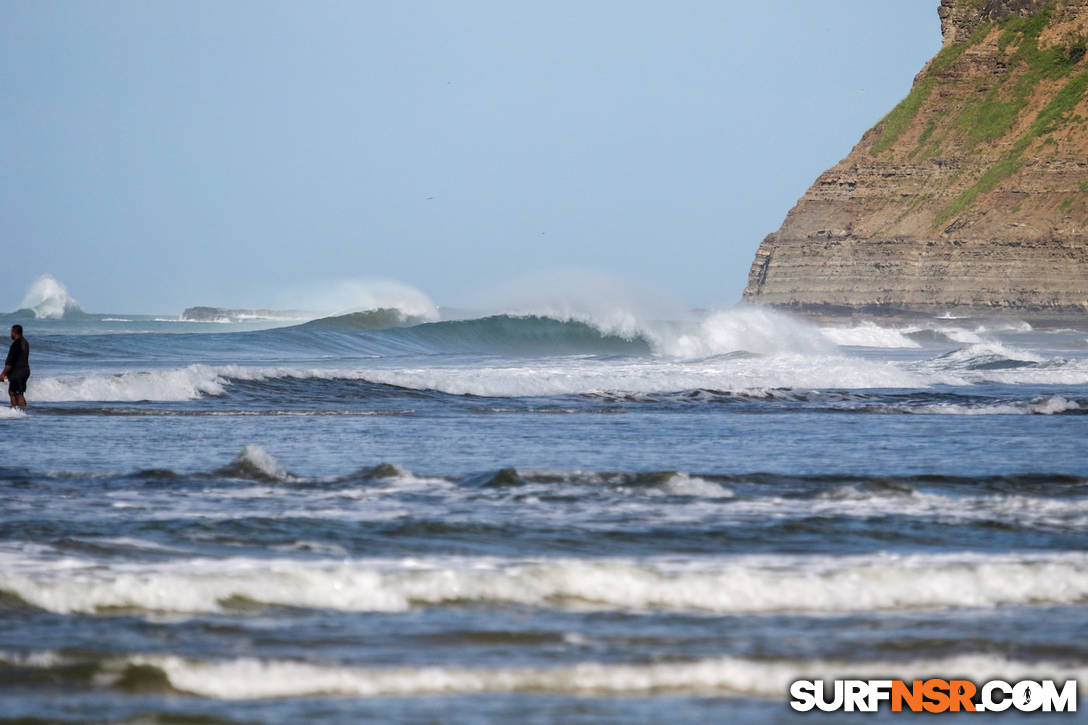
(0, 651), (1088, 700)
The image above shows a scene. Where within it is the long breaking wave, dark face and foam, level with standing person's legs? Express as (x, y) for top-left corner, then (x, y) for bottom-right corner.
(27, 363), (1088, 402)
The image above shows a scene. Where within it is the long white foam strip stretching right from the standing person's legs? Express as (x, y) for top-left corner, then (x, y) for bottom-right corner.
(27, 352), (1088, 400)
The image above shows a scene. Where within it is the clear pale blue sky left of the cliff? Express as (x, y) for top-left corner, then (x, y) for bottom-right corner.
(0, 0), (940, 312)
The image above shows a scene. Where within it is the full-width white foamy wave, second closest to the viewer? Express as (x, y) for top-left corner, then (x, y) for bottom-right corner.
(0, 552), (1088, 615)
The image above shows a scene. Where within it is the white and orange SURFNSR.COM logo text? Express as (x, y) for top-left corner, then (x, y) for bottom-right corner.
(790, 678), (1077, 713)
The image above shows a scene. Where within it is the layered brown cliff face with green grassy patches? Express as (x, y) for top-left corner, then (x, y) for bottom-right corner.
(744, 0), (1088, 314)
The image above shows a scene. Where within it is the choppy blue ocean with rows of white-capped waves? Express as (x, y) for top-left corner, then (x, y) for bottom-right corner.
(0, 307), (1088, 724)
